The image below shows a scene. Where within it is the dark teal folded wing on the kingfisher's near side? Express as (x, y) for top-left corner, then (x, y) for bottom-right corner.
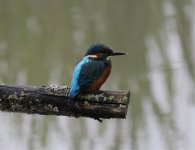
(78, 60), (105, 91)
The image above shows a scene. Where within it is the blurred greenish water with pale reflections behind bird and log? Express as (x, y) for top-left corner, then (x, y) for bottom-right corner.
(0, 0), (195, 150)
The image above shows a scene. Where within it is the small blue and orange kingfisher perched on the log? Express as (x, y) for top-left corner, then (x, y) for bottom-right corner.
(68, 43), (127, 98)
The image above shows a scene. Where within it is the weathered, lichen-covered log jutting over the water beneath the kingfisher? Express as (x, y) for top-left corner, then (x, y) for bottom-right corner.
(0, 84), (130, 121)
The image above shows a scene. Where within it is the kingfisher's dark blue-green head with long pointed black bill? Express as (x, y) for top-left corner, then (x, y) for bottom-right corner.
(85, 43), (127, 59)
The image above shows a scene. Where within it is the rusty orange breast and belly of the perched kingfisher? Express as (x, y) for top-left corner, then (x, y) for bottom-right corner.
(88, 65), (111, 92)
